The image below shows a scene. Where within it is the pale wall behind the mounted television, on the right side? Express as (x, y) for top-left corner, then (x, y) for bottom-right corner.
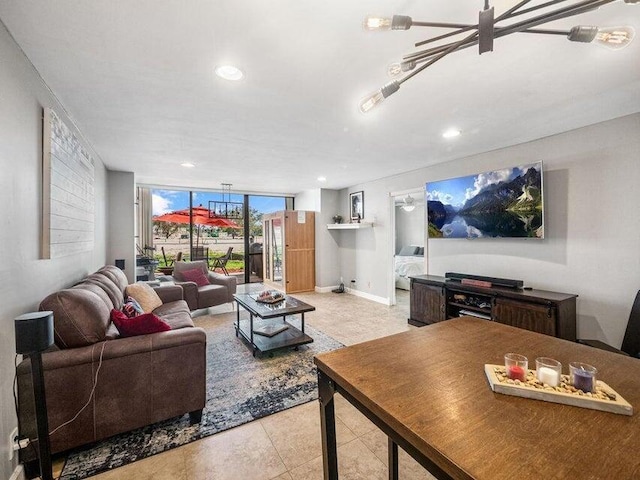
(340, 114), (640, 346)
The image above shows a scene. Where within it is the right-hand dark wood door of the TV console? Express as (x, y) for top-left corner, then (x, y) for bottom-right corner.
(492, 297), (556, 337)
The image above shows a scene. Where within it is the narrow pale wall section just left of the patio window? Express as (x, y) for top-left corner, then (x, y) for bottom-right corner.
(106, 171), (136, 283)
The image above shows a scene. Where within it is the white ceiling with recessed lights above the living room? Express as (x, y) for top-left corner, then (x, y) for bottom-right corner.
(0, 0), (640, 193)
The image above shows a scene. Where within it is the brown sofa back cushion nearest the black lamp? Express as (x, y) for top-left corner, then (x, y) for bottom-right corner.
(40, 288), (109, 348)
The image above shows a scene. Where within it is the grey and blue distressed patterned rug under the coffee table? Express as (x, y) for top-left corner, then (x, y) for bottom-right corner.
(60, 313), (343, 480)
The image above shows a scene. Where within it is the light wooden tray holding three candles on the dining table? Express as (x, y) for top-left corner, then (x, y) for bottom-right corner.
(484, 364), (633, 416)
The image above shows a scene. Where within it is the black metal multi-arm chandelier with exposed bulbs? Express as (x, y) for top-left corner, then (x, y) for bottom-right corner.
(359, 0), (640, 113)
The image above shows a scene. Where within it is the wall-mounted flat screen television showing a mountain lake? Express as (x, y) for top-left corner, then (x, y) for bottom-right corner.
(426, 162), (544, 238)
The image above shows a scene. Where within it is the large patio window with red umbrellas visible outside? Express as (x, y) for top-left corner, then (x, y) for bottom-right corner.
(147, 189), (293, 283)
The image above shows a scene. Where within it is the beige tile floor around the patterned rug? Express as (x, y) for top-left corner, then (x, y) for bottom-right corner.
(56, 291), (433, 480)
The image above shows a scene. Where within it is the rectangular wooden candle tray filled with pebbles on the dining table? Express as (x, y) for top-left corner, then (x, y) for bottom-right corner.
(484, 364), (633, 416)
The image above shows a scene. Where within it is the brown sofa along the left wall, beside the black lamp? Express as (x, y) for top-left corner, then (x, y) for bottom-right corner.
(18, 266), (206, 461)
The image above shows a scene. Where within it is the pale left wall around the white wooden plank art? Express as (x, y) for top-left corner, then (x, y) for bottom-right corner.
(0, 22), (107, 478)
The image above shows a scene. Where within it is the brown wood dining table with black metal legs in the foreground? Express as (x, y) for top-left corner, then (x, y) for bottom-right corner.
(315, 317), (640, 480)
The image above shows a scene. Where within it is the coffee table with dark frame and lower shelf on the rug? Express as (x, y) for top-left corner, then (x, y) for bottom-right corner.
(233, 292), (316, 357)
